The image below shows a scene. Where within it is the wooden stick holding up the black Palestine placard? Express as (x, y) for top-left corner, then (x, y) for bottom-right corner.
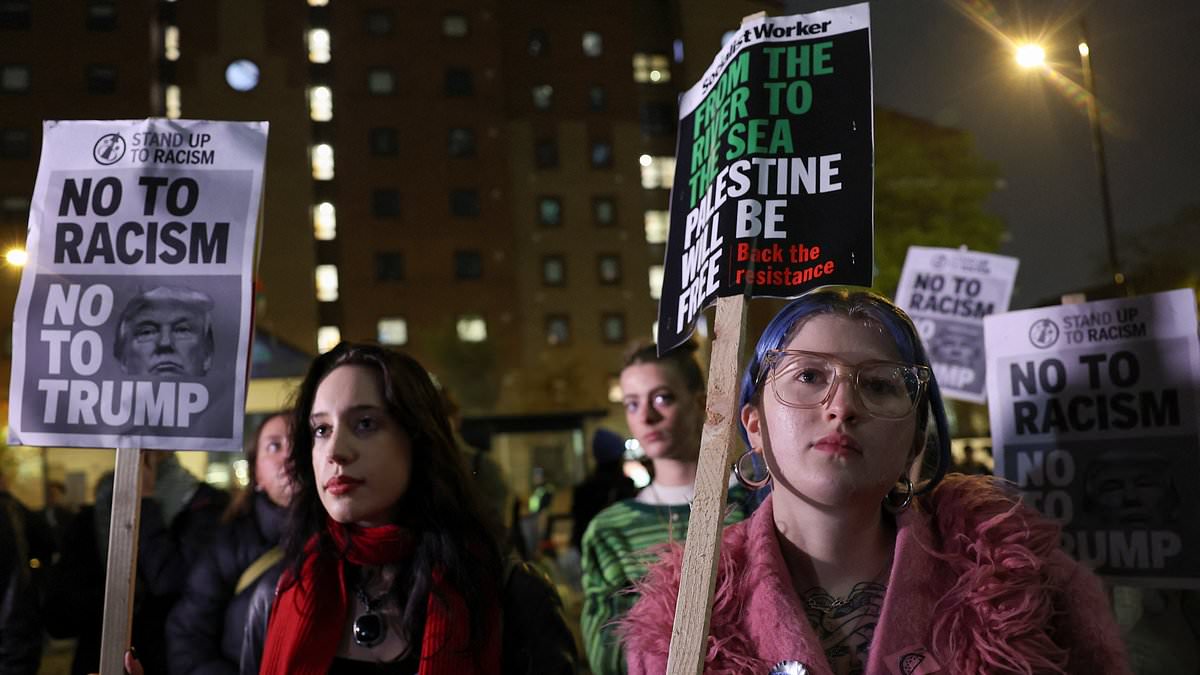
(667, 295), (748, 675)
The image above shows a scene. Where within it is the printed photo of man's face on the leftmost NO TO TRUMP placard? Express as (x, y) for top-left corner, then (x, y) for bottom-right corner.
(113, 286), (214, 378)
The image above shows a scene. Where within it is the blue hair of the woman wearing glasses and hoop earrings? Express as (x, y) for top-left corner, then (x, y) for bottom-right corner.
(739, 286), (950, 495)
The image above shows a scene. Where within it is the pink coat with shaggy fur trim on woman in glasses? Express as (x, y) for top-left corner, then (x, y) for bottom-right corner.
(620, 474), (1129, 675)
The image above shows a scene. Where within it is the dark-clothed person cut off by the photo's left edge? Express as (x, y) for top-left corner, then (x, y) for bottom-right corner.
(0, 482), (42, 675)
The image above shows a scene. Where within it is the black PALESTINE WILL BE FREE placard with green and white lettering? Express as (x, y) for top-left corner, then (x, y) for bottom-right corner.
(659, 2), (874, 351)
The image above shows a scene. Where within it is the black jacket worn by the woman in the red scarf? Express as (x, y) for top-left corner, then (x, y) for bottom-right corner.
(241, 558), (578, 675)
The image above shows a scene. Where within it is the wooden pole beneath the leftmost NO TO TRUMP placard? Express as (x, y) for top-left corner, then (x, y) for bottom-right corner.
(100, 448), (143, 675)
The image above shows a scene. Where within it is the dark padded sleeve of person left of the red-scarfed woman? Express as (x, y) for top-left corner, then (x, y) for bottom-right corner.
(167, 546), (238, 675)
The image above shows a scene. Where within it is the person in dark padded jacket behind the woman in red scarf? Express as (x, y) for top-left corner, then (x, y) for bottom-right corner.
(167, 413), (292, 675)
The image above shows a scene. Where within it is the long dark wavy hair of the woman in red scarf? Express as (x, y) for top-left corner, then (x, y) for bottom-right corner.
(284, 342), (500, 645)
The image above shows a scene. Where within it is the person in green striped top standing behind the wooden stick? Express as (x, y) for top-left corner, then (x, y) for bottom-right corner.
(581, 342), (749, 675)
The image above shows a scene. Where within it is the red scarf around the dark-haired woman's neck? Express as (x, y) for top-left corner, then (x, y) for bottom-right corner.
(259, 520), (500, 675)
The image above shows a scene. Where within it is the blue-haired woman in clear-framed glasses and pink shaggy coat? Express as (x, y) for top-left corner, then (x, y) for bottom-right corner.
(622, 287), (1128, 675)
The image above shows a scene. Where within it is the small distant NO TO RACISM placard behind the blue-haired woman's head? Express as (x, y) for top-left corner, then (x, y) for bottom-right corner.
(896, 246), (1019, 404)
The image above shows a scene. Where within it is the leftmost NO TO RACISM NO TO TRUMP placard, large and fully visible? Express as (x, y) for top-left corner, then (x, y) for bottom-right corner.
(8, 119), (266, 450)
